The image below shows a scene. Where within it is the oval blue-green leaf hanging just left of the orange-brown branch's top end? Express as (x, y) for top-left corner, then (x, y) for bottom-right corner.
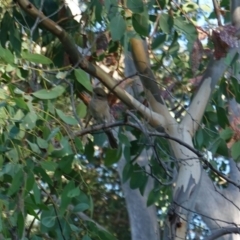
(109, 14), (126, 41)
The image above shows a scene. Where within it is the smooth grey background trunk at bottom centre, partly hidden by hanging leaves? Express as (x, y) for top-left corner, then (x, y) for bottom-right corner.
(118, 50), (160, 240)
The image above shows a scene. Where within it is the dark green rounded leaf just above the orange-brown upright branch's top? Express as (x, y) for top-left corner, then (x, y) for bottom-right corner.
(132, 12), (150, 36)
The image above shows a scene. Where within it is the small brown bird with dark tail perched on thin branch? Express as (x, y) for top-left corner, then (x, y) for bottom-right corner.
(88, 87), (118, 148)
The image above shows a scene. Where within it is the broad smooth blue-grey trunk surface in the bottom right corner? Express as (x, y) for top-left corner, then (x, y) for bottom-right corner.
(194, 169), (240, 240)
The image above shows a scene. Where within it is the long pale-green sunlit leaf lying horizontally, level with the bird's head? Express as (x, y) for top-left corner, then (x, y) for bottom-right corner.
(32, 86), (65, 100)
